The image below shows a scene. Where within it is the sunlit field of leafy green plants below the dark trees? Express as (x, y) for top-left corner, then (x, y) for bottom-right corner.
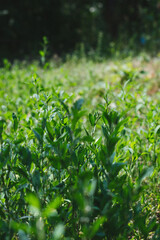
(0, 54), (160, 240)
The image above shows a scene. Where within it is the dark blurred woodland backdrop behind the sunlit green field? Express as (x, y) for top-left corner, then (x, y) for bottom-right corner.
(0, 0), (160, 59)
